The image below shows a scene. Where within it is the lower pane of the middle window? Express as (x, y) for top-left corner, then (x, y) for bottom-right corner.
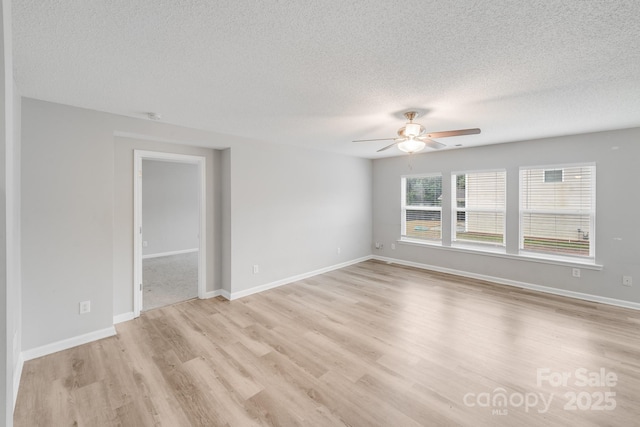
(456, 211), (504, 245)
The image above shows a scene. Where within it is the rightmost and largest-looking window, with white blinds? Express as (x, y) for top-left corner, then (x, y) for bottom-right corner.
(520, 165), (595, 258)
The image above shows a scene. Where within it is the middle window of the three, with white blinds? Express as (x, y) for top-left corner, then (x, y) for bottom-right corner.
(452, 170), (506, 246)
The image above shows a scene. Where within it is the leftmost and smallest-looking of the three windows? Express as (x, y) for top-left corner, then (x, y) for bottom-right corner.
(402, 175), (442, 240)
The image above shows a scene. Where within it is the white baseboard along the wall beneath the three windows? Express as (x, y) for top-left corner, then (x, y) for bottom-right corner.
(371, 255), (640, 310)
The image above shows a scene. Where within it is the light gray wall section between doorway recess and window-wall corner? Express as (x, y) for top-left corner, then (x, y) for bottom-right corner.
(228, 140), (372, 293)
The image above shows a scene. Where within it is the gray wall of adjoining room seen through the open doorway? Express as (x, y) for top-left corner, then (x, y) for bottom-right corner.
(142, 159), (200, 256)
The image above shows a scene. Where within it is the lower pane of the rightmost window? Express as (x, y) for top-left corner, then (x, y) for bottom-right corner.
(522, 213), (591, 256)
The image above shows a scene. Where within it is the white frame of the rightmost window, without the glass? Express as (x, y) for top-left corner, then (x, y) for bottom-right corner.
(518, 162), (597, 263)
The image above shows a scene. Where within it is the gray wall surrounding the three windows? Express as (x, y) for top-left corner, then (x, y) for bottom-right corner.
(373, 128), (640, 303)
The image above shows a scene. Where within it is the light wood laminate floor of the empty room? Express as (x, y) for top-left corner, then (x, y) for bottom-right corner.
(14, 261), (640, 427)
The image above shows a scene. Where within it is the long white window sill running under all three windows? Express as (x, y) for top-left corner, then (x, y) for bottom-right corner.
(396, 238), (603, 270)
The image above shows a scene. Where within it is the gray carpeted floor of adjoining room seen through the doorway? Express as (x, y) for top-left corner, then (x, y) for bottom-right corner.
(142, 252), (198, 311)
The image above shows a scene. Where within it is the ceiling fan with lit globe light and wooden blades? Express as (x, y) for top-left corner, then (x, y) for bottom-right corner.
(353, 111), (480, 154)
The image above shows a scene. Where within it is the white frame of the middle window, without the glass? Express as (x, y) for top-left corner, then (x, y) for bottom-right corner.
(450, 169), (507, 250)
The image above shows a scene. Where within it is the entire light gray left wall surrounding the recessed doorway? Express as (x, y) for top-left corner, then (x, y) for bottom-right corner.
(22, 98), (372, 350)
